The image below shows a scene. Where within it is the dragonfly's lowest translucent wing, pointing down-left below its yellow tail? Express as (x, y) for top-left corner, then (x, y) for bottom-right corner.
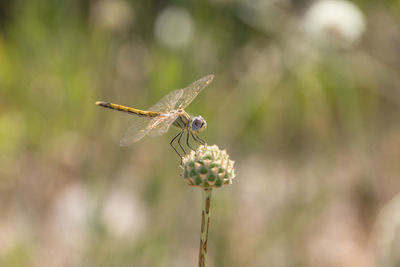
(119, 117), (153, 146)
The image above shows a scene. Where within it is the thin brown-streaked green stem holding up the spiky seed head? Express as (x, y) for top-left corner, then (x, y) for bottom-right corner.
(199, 188), (212, 267)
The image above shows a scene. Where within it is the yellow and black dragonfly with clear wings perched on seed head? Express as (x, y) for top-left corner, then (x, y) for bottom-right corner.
(96, 74), (214, 158)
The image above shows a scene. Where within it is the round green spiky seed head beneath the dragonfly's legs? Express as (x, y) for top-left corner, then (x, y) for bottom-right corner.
(181, 145), (235, 188)
